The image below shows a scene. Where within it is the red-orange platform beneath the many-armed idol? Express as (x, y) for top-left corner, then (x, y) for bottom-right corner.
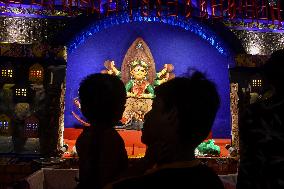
(63, 128), (238, 175)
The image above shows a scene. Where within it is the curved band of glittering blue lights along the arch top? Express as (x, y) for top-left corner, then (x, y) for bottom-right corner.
(67, 12), (229, 56)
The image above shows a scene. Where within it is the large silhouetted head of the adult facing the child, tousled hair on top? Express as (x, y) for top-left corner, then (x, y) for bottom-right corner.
(142, 68), (220, 148)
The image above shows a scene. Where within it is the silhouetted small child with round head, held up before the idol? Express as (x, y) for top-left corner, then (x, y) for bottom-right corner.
(76, 74), (128, 188)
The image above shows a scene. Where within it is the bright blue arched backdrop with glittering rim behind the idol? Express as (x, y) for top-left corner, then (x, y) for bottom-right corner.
(65, 14), (234, 138)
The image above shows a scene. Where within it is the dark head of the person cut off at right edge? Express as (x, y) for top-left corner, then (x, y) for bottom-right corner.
(262, 49), (284, 94)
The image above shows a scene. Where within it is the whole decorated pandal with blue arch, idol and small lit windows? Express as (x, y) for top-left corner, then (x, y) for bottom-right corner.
(0, 0), (284, 188)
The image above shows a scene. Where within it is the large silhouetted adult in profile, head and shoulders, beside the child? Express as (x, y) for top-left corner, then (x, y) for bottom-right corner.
(106, 70), (224, 189)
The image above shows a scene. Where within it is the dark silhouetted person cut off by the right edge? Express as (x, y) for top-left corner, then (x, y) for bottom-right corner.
(237, 50), (284, 189)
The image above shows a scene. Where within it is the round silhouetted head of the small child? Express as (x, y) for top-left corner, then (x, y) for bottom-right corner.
(79, 73), (126, 125)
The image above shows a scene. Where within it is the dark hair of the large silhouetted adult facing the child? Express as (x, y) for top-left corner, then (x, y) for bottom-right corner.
(155, 69), (220, 146)
